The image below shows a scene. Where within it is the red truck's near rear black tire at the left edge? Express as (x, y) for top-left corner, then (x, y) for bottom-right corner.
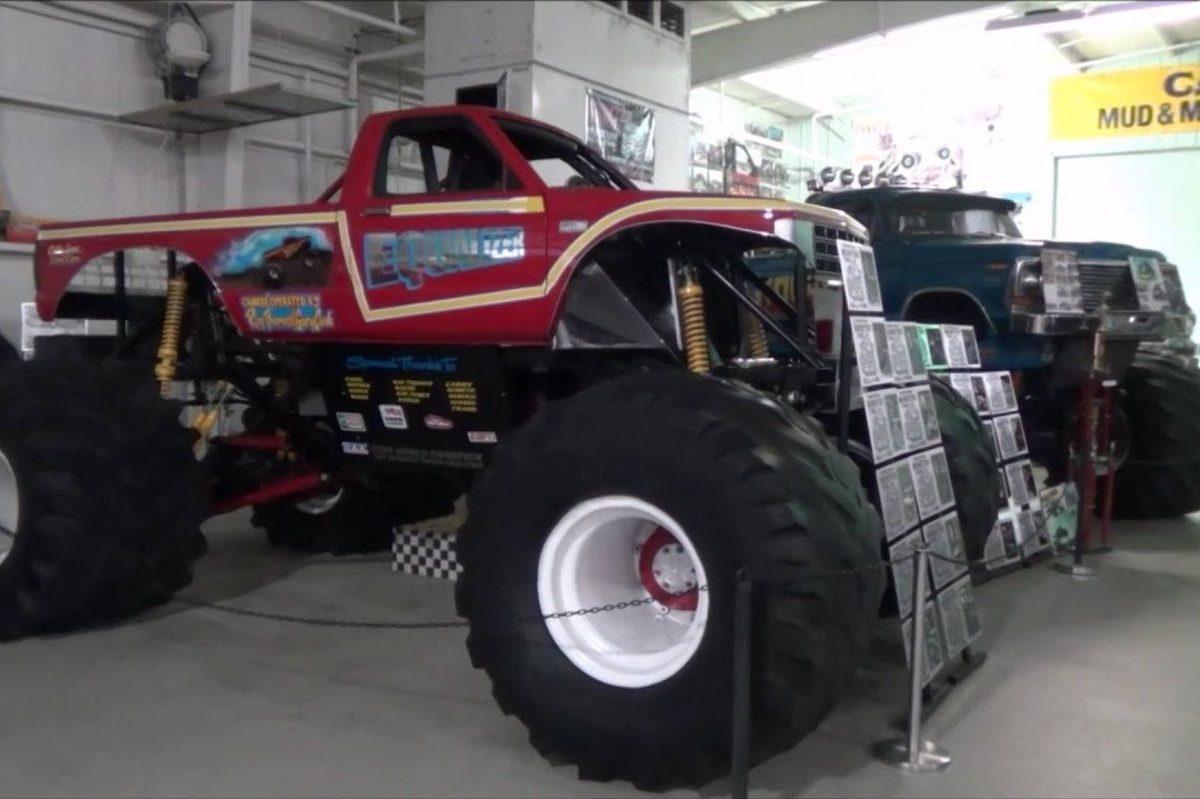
(0, 361), (208, 638)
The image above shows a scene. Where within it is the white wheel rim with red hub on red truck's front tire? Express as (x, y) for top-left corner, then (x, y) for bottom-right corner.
(538, 497), (709, 687)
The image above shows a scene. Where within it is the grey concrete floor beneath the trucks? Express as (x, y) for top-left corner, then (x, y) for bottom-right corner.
(0, 516), (1200, 797)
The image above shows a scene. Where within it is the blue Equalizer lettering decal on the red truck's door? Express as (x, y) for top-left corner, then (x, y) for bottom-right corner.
(362, 227), (526, 292)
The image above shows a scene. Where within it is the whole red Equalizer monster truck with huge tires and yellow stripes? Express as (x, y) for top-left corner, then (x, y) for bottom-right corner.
(0, 107), (884, 787)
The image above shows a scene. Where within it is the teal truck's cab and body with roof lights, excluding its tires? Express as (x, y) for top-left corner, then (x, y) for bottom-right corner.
(809, 187), (1194, 382)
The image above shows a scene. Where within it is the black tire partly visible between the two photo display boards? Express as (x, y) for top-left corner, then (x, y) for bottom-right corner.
(929, 378), (1002, 560)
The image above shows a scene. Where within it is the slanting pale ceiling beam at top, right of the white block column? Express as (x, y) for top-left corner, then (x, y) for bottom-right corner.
(691, 0), (1002, 86)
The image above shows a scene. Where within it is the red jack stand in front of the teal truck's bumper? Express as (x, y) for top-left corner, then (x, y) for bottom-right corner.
(1055, 313), (1116, 577)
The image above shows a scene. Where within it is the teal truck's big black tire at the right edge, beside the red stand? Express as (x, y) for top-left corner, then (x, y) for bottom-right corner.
(1112, 352), (1200, 518)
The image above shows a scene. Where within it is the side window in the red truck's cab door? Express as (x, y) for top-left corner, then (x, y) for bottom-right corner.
(374, 116), (521, 196)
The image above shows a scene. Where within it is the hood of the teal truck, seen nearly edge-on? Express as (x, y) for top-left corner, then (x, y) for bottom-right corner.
(876, 236), (1166, 264)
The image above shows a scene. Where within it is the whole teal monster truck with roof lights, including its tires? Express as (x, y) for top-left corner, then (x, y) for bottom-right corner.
(755, 187), (1200, 518)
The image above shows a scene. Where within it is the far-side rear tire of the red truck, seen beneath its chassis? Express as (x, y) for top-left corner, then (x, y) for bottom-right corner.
(251, 480), (460, 555)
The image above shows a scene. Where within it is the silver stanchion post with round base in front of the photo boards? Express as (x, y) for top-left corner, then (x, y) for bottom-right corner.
(875, 543), (950, 774)
